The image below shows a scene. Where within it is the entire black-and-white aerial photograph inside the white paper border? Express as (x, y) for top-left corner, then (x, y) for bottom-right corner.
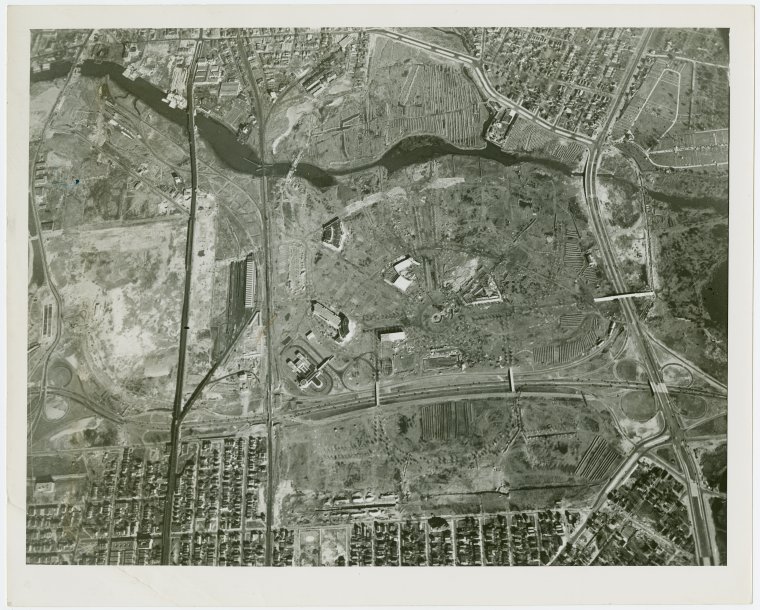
(28, 27), (738, 573)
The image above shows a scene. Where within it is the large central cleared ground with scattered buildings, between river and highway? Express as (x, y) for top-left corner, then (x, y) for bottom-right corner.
(275, 157), (609, 392)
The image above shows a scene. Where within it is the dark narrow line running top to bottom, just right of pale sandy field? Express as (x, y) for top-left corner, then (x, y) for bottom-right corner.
(161, 41), (203, 565)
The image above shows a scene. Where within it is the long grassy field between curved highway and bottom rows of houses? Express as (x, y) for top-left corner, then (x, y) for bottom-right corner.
(280, 398), (624, 524)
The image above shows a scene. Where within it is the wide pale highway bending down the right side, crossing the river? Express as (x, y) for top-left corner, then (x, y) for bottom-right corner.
(583, 29), (713, 564)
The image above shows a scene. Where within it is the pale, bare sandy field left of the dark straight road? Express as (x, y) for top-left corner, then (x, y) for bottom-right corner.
(45, 217), (184, 407)
